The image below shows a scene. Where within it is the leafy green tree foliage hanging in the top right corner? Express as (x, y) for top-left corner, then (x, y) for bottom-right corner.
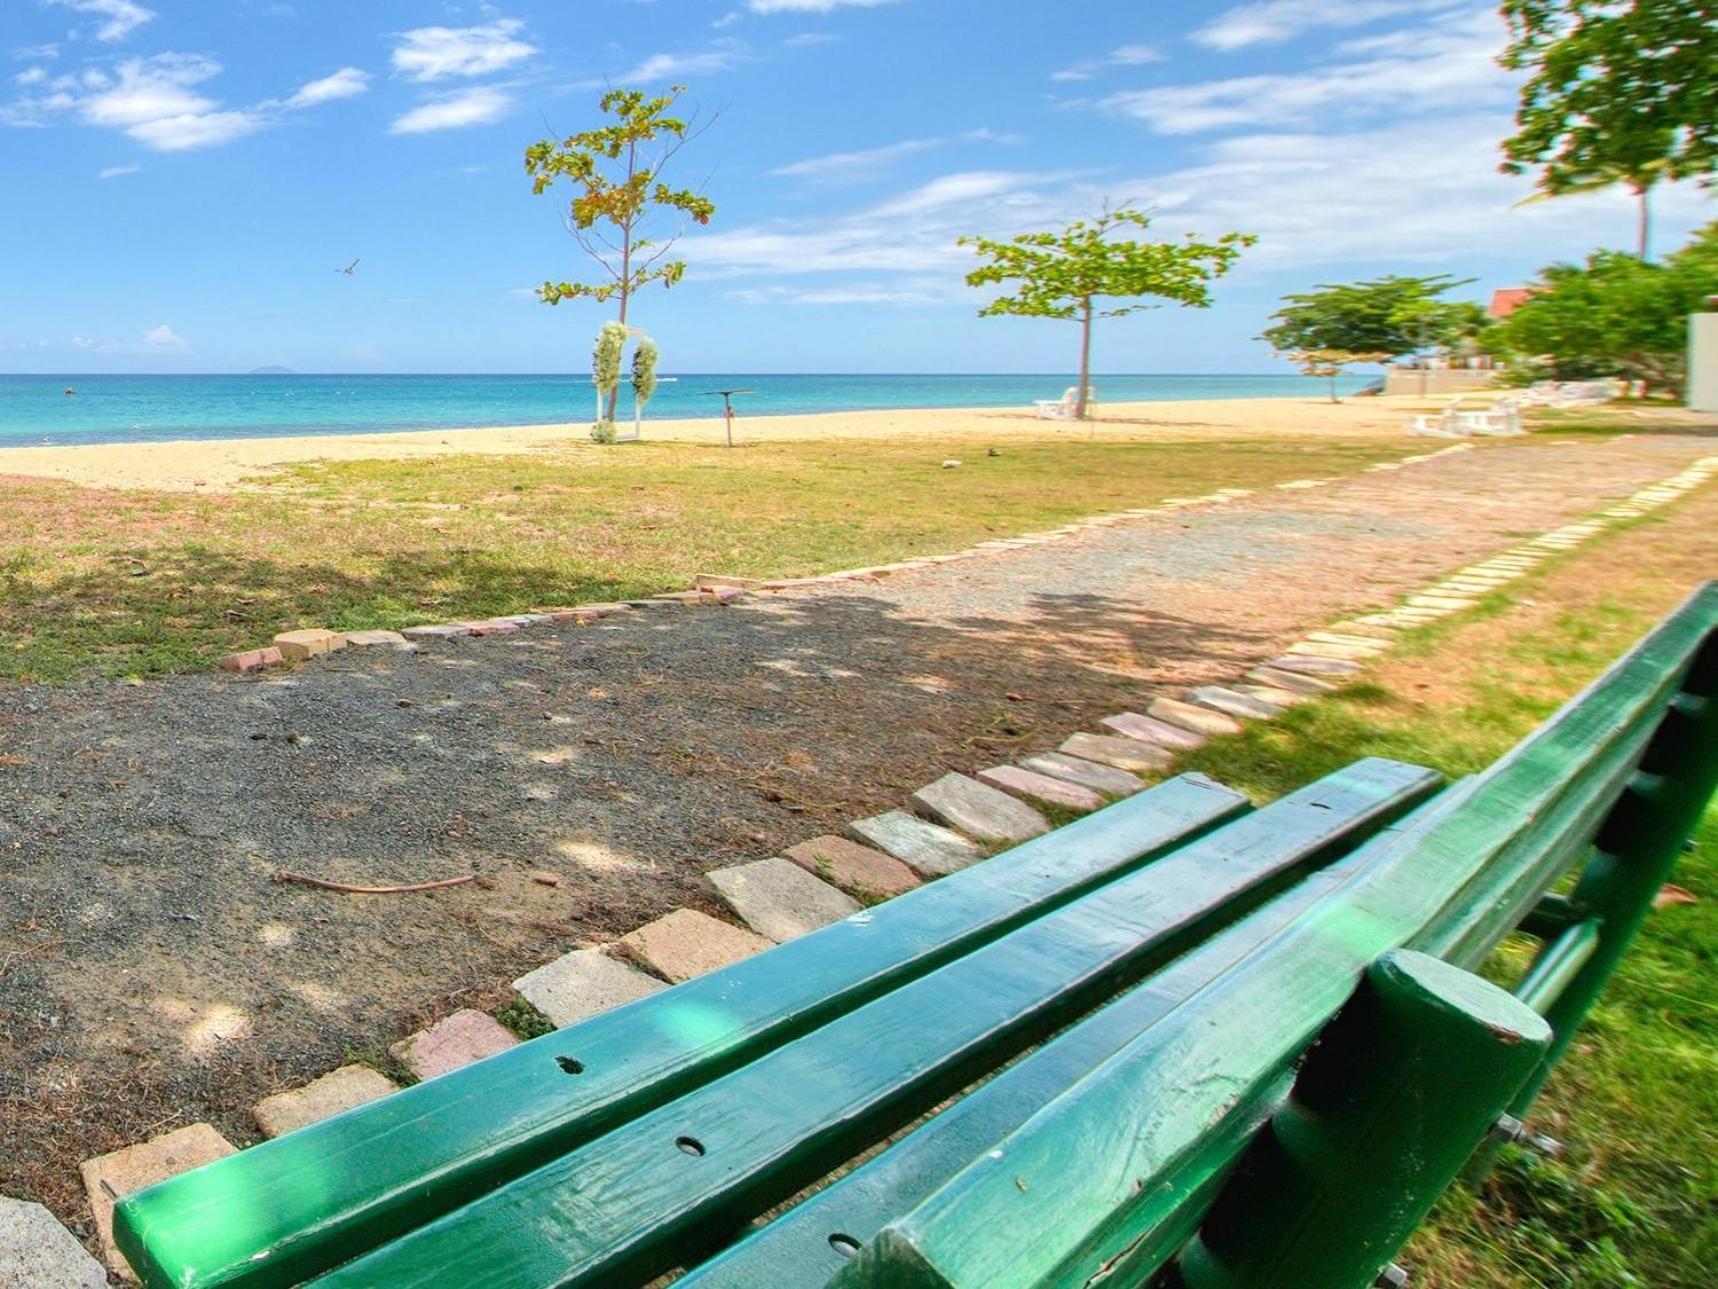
(1502, 0), (1718, 260)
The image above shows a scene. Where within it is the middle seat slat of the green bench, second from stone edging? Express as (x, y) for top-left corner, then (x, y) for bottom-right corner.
(316, 760), (1438, 1289)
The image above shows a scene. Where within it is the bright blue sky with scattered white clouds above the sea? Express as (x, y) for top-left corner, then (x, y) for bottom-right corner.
(0, 0), (1713, 373)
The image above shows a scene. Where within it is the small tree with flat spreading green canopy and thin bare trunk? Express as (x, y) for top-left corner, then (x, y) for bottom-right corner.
(960, 205), (1258, 419)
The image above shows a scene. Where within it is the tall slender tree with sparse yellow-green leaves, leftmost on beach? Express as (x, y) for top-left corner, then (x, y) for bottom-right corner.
(526, 86), (716, 421)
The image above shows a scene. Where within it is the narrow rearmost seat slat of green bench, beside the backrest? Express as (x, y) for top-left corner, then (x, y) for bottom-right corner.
(675, 856), (1395, 1289)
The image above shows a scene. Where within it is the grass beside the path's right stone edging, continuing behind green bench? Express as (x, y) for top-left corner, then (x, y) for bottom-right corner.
(1177, 488), (1718, 1289)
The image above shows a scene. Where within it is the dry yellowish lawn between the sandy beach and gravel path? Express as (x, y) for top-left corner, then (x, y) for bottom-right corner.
(0, 437), (1426, 681)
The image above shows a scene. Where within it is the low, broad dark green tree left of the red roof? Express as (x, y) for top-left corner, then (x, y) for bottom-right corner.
(1259, 273), (1483, 363)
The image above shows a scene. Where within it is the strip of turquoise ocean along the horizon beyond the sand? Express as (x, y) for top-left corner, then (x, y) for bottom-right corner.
(0, 375), (1368, 447)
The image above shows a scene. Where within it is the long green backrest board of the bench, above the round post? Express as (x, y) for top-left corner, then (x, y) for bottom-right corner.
(833, 586), (1718, 1289)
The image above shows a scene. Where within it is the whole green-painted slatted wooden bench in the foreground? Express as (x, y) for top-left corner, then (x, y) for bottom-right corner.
(115, 584), (1718, 1289)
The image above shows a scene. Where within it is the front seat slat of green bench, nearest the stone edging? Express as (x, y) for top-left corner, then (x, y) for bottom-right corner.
(115, 775), (1247, 1289)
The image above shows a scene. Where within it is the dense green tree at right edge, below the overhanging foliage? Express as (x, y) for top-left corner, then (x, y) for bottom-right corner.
(1502, 223), (1718, 397)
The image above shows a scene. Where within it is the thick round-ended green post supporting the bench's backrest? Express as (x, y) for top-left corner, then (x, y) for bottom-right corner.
(1179, 950), (1551, 1289)
